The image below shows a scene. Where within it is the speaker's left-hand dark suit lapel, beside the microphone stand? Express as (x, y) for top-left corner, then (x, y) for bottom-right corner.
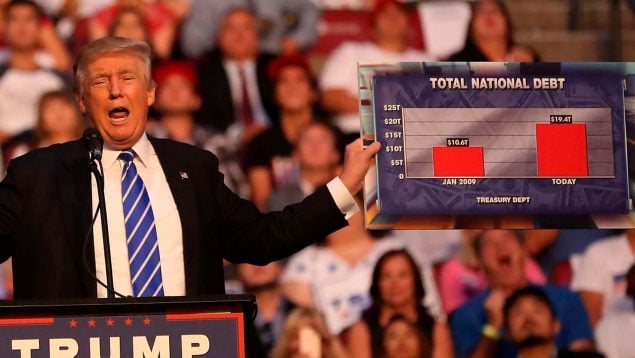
(57, 141), (97, 297)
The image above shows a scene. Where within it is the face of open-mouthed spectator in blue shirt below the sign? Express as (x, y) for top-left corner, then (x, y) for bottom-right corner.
(479, 230), (526, 288)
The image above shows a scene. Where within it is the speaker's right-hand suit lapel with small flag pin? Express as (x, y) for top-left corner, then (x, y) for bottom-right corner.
(148, 137), (200, 295)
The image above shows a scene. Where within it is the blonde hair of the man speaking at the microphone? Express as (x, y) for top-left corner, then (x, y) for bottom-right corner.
(73, 37), (154, 96)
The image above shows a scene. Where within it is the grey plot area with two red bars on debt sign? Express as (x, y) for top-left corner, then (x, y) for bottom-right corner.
(403, 108), (615, 178)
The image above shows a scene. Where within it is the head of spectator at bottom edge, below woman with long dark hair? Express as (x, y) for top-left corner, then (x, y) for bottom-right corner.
(381, 314), (430, 358)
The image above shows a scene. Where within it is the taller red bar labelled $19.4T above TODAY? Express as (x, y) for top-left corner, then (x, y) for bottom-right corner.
(536, 123), (589, 177)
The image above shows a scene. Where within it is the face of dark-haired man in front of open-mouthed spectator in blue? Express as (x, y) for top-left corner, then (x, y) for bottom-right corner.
(507, 295), (560, 345)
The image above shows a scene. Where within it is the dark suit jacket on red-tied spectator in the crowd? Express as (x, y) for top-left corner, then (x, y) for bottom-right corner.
(196, 49), (278, 131)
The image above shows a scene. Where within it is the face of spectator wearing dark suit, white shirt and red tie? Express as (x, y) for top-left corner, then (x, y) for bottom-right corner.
(218, 10), (258, 61)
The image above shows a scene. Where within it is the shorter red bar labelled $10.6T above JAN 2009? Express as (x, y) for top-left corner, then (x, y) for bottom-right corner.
(432, 147), (485, 177)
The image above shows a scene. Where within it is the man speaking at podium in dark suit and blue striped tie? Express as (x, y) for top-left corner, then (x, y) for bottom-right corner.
(0, 37), (379, 299)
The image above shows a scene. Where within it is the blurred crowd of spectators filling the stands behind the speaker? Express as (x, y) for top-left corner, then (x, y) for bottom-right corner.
(0, 0), (635, 358)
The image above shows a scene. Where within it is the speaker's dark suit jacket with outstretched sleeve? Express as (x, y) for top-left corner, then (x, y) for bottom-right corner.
(0, 138), (346, 299)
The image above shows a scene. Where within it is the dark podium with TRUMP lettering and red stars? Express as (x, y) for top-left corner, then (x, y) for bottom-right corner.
(0, 295), (257, 358)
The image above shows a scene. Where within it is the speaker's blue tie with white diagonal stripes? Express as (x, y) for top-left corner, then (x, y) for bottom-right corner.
(119, 149), (164, 297)
